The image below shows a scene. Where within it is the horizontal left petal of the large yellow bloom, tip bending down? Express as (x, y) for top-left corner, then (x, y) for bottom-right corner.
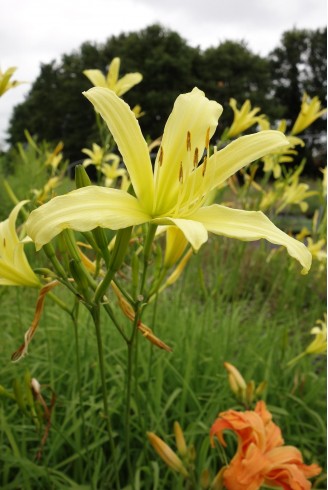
(26, 186), (150, 249)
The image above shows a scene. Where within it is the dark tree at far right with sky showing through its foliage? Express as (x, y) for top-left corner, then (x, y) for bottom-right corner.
(269, 28), (327, 172)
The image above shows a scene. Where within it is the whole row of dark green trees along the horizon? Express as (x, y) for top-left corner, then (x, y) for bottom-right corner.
(8, 24), (327, 171)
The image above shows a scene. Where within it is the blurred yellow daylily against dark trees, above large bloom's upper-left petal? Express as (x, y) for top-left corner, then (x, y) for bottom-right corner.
(83, 58), (142, 97)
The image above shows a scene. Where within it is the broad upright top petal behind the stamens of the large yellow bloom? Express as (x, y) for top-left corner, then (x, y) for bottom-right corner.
(154, 88), (222, 214)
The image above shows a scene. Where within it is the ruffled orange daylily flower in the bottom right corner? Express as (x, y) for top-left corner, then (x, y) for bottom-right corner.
(210, 401), (321, 490)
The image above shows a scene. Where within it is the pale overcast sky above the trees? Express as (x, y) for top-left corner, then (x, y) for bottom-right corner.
(0, 0), (327, 147)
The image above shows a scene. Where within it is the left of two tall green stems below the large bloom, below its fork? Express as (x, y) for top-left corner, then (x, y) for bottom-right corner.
(91, 305), (121, 490)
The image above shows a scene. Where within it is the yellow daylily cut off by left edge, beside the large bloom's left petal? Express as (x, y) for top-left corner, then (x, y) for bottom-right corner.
(0, 201), (40, 287)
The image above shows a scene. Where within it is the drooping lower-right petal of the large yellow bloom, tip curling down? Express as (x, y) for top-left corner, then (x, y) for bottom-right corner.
(190, 204), (312, 274)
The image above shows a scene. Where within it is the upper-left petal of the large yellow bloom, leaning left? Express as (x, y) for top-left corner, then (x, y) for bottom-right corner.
(83, 87), (154, 212)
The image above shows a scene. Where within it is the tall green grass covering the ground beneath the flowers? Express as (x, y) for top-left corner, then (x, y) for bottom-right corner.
(0, 238), (326, 490)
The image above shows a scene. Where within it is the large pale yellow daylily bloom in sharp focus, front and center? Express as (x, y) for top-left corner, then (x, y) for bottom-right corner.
(26, 87), (311, 273)
